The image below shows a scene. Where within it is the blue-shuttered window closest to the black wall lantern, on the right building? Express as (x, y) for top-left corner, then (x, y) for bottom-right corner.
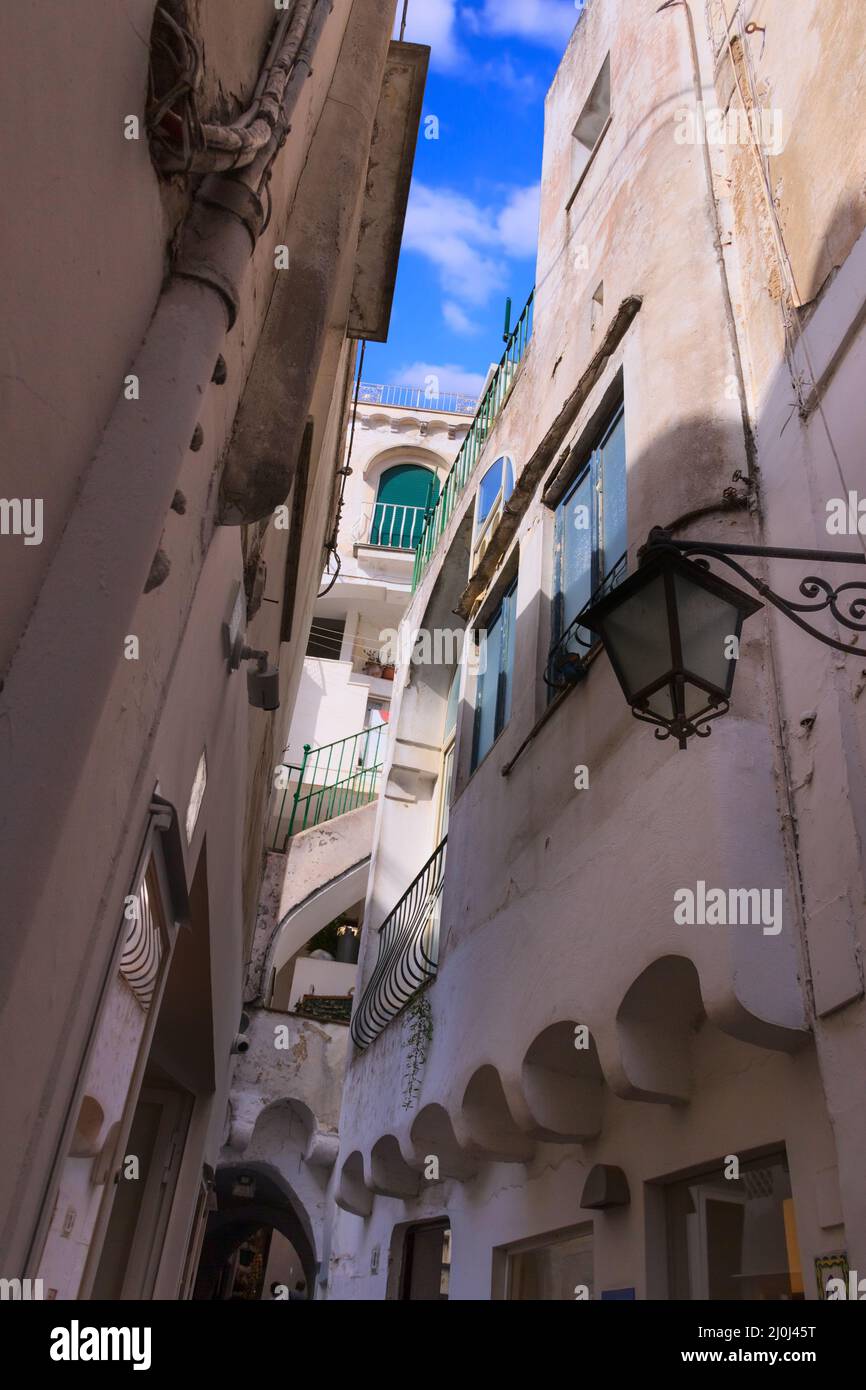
(546, 402), (628, 688)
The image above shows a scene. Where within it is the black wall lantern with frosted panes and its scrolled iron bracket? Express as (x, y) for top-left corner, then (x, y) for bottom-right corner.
(581, 527), (866, 748)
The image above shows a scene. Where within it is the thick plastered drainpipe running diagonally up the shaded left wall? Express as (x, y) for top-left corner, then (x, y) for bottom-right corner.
(0, 0), (332, 956)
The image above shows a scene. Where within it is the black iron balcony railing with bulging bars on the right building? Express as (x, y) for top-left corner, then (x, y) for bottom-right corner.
(349, 835), (448, 1051)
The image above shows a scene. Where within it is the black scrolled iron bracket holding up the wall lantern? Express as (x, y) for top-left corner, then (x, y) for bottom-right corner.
(638, 527), (866, 661)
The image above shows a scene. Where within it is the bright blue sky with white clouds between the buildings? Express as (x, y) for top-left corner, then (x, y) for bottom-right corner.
(364, 0), (581, 393)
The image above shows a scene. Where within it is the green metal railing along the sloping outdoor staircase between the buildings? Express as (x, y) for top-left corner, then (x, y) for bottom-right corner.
(272, 724), (388, 852)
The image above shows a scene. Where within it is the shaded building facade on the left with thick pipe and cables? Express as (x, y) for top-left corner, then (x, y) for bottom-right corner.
(0, 0), (428, 1298)
